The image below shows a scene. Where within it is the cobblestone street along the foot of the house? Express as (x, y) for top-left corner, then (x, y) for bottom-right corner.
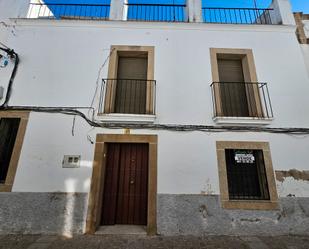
(0, 235), (309, 249)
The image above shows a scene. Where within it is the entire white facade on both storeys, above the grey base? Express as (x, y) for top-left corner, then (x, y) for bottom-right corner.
(0, 20), (309, 194)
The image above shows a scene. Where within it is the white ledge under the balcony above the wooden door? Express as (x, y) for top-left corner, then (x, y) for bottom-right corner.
(97, 113), (156, 124)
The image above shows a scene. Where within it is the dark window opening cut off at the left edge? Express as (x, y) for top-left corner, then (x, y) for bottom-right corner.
(0, 118), (20, 183)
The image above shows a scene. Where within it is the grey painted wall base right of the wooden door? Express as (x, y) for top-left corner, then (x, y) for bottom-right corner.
(158, 194), (309, 236)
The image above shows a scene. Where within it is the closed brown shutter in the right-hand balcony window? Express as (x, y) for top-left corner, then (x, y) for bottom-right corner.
(218, 59), (249, 117)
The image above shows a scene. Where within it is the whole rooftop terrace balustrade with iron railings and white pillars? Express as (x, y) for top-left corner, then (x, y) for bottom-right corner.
(23, 0), (288, 25)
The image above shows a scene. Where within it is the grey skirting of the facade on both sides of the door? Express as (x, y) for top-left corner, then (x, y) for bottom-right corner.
(0, 192), (309, 236)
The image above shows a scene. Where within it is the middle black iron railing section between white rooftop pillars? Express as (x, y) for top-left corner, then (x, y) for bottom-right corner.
(126, 3), (187, 22)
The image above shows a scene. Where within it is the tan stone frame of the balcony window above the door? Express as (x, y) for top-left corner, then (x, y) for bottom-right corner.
(100, 45), (155, 115)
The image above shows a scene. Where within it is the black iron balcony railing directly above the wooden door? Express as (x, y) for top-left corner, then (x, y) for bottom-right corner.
(99, 79), (156, 115)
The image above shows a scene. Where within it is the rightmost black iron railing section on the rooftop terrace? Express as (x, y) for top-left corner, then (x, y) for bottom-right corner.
(202, 7), (273, 24)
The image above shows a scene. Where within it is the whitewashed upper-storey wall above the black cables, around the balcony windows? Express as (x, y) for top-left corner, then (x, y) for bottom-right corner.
(4, 20), (309, 127)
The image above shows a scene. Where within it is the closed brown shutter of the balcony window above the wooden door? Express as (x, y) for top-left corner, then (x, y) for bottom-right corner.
(115, 57), (148, 114)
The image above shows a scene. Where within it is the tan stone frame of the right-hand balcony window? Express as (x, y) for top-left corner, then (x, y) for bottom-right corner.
(210, 48), (264, 118)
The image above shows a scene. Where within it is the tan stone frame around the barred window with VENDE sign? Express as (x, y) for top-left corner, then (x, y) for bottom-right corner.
(216, 141), (279, 210)
